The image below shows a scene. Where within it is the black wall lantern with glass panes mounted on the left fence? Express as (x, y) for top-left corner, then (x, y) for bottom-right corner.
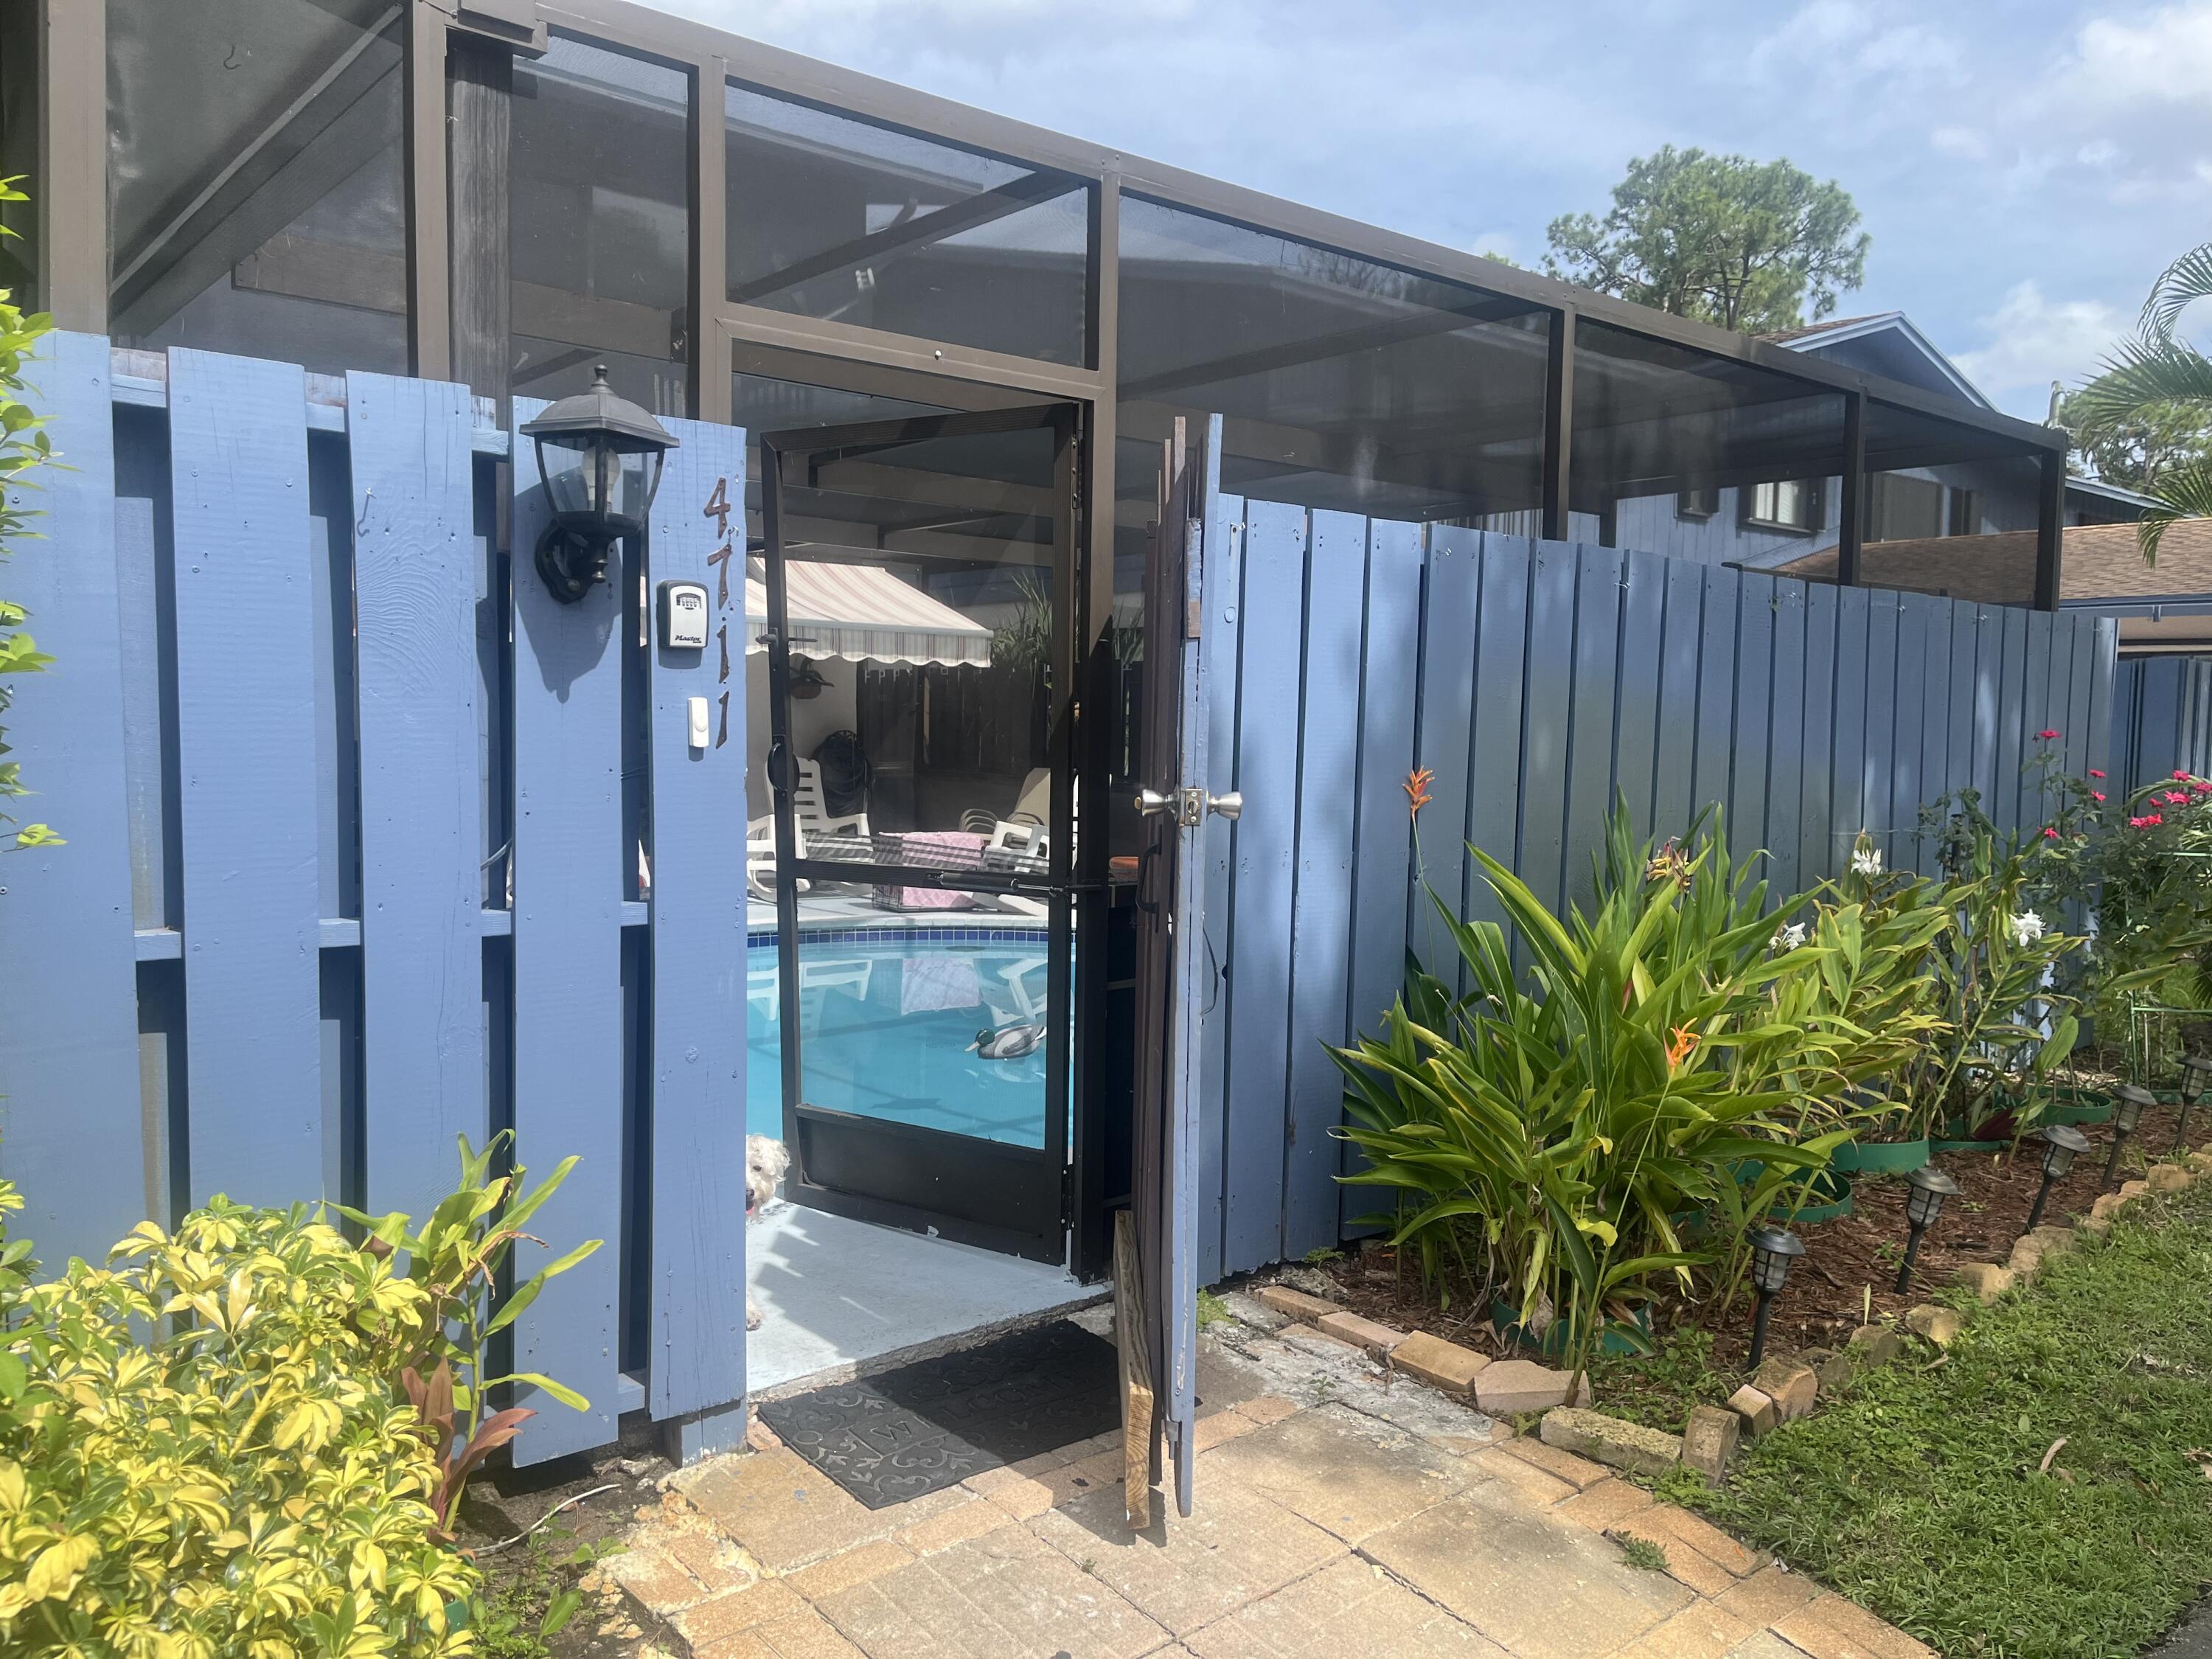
(522, 363), (677, 604)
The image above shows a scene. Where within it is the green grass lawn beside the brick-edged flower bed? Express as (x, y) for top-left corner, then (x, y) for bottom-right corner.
(1677, 1181), (2212, 1659)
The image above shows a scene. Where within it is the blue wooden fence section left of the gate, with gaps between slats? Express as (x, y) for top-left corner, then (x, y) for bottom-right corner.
(0, 334), (745, 1460)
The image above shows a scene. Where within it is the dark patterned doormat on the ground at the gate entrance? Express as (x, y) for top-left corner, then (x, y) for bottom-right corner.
(761, 1318), (1121, 1509)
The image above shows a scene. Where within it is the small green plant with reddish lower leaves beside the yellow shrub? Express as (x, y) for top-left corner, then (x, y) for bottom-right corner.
(332, 1130), (602, 1526)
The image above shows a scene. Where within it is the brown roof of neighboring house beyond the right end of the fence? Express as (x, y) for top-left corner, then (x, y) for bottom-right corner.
(1774, 518), (2212, 613)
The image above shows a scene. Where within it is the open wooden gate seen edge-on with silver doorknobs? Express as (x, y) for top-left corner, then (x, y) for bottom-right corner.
(1135, 416), (1243, 1515)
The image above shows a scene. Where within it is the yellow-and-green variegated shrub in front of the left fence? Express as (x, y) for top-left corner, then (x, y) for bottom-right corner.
(0, 1190), (478, 1659)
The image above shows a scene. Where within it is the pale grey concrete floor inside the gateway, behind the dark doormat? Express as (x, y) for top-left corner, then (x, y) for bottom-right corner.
(745, 1201), (1104, 1396)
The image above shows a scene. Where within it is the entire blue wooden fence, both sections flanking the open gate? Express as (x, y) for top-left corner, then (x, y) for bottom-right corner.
(0, 336), (2132, 1458)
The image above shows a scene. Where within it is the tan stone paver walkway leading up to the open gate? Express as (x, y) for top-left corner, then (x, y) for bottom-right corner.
(606, 1327), (1929, 1659)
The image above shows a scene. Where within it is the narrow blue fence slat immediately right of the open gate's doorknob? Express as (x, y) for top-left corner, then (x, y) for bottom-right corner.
(1197, 493), (1245, 1285)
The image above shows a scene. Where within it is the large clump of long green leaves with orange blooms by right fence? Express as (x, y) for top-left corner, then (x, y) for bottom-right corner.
(1332, 803), (1854, 1398)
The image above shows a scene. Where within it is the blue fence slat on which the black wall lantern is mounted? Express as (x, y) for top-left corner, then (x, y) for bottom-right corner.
(511, 398), (637, 1464)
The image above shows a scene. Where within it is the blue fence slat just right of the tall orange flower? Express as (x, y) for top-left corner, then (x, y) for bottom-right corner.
(1409, 524), (1484, 929)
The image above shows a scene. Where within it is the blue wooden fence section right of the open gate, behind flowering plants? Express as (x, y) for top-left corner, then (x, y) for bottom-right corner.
(1199, 520), (2115, 1283)
